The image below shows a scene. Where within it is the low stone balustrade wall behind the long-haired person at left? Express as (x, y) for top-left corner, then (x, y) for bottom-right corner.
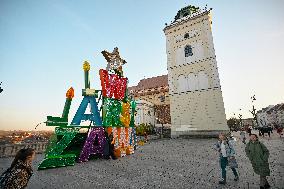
(0, 142), (47, 157)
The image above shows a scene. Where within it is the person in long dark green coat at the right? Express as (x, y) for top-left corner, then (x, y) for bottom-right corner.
(245, 134), (270, 189)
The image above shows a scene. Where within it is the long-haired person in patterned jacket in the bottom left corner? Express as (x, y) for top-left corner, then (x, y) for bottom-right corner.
(0, 148), (35, 189)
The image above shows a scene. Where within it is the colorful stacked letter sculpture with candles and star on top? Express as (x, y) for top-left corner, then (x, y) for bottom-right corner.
(38, 48), (136, 169)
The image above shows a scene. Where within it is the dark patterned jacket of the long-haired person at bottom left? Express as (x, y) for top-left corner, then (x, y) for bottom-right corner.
(0, 160), (33, 189)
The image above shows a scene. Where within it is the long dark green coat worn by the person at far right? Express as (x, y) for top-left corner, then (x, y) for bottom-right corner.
(245, 140), (270, 176)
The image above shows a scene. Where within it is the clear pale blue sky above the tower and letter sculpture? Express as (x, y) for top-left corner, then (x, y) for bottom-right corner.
(0, 0), (284, 130)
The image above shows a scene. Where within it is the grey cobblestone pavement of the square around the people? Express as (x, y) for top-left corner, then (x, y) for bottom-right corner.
(0, 133), (284, 189)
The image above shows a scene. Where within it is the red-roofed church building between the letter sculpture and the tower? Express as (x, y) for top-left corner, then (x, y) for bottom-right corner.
(128, 75), (171, 125)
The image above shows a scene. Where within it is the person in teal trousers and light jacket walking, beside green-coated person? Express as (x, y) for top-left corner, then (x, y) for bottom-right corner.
(215, 133), (239, 184)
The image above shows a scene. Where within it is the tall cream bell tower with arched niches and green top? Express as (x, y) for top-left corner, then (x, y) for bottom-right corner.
(164, 6), (229, 138)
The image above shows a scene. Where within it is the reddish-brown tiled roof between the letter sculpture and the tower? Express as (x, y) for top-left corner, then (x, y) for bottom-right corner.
(128, 75), (169, 91)
